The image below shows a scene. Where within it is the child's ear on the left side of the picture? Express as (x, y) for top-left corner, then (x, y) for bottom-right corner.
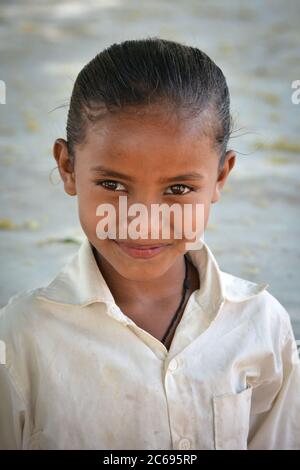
(53, 139), (76, 196)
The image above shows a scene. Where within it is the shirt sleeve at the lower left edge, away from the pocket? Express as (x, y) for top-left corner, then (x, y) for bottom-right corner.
(0, 364), (27, 450)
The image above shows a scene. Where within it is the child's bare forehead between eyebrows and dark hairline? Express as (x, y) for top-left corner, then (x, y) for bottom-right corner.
(79, 111), (218, 171)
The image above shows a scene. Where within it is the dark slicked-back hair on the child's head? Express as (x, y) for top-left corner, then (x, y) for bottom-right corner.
(66, 37), (231, 166)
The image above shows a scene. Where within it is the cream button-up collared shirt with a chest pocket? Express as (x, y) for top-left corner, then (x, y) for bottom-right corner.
(0, 238), (300, 450)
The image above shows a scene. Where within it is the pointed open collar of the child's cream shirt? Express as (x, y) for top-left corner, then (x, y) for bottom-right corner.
(38, 237), (268, 311)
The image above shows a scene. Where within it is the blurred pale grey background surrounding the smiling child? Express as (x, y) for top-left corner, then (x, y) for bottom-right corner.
(0, 0), (300, 339)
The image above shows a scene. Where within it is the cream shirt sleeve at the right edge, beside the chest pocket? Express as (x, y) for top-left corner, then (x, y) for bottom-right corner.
(248, 315), (300, 450)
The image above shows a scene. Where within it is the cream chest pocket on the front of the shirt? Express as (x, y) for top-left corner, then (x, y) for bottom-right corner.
(213, 385), (253, 450)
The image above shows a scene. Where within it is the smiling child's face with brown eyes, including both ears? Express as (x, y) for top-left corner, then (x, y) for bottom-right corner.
(53, 108), (235, 280)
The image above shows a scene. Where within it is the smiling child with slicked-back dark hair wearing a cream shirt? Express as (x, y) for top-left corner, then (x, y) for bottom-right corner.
(0, 38), (300, 450)
